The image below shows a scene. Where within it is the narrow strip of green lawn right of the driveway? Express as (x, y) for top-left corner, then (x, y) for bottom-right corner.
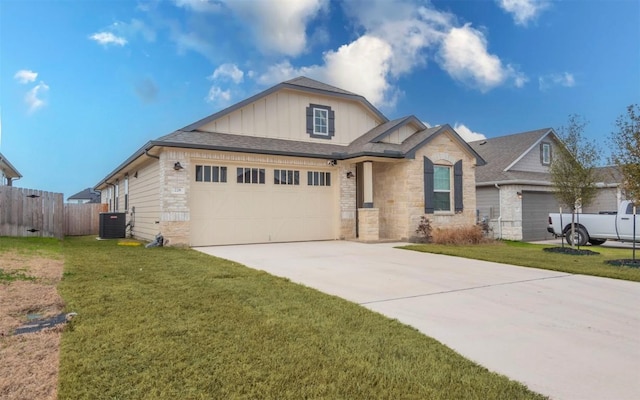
(402, 241), (640, 282)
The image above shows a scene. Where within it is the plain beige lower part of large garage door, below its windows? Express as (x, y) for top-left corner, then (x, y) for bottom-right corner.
(191, 169), (337, 246)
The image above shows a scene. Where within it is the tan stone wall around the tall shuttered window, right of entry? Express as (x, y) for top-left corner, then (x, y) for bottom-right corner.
(373, 134), (476, 240)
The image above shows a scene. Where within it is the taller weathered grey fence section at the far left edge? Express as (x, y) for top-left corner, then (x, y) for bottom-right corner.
(0, 186), (64, 239)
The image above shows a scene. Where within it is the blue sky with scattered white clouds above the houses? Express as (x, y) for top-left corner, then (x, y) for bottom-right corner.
(0, 0), (640, 198)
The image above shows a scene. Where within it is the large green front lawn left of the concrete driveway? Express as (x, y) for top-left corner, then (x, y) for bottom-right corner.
(48, 238), (543, 400)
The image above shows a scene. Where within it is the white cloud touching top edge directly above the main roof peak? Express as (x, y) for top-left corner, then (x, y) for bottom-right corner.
(226, 0), (329, 56)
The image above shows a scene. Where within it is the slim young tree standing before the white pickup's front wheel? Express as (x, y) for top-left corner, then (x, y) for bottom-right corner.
(549, 114), (602, 246)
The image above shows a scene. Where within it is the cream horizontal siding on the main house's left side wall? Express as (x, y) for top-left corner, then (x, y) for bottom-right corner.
(125, 160), (160, 240)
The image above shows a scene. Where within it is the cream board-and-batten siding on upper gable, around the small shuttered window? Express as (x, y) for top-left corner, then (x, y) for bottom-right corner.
(199, 90), (382, 145)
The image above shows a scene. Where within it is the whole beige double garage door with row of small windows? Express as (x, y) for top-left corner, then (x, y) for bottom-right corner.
(190, 164), (338, 246)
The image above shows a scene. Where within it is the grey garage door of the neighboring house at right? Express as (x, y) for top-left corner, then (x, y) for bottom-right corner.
(522, 191), (558, 241)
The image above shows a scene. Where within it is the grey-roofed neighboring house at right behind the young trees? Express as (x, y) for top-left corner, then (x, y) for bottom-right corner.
(469, 128), (622, 241)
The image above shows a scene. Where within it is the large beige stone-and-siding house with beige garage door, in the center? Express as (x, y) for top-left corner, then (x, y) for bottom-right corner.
(96, 77), (484, 246)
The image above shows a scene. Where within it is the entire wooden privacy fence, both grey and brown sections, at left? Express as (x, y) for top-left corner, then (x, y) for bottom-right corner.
(0, 186), (107, 239)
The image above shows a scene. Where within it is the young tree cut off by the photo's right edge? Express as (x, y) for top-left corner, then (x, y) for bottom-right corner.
(610, 104), (640, 202)
